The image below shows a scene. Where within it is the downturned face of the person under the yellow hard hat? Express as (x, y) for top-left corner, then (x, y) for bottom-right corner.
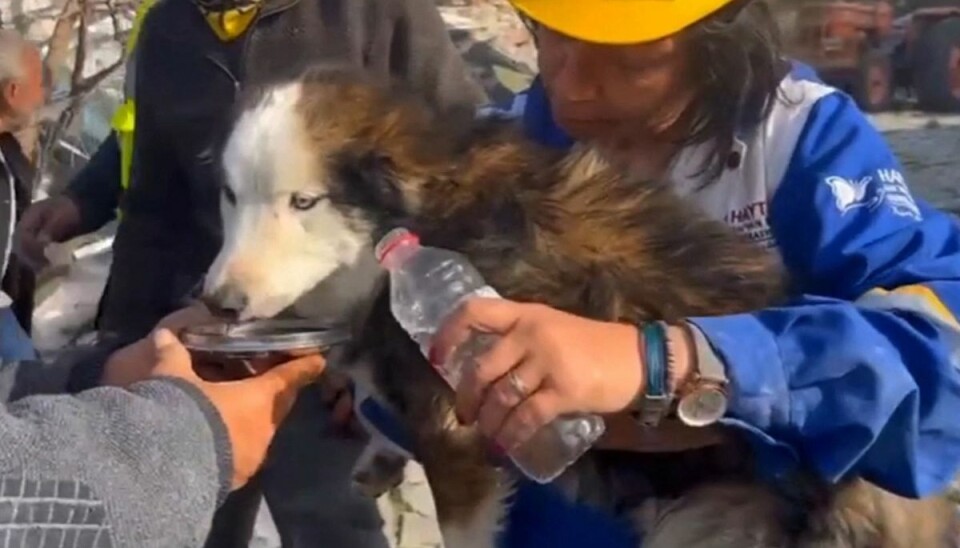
(534, 25), (691, 148)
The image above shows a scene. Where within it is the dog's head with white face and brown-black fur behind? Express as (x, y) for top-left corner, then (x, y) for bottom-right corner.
(204, 69), (450, 320)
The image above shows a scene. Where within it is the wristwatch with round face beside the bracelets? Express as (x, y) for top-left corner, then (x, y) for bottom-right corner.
(677, 324), (729, 427)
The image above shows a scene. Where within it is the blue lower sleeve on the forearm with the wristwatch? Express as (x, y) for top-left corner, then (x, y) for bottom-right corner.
(692, 298), (960, 496)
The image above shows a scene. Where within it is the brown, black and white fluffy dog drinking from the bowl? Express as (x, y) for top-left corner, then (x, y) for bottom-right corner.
(206, 69), (954, 548)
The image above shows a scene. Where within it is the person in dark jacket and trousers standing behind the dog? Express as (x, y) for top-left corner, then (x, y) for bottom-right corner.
(20, 0), (486, 548)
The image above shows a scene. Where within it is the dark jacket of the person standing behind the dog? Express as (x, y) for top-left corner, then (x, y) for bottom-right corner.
(77, 0), (484, 340)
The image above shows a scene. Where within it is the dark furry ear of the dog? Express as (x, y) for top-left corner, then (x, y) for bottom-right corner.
(330, 150), (408, 221)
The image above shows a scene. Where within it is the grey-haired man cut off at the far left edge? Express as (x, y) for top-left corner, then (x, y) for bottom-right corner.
(0, 29), (46, 360)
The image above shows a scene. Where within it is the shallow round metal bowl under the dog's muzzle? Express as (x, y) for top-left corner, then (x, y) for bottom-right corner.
(180, 320), (350, 377)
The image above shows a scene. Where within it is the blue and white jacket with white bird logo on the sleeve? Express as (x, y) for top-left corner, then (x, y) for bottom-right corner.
(498, 67), (960, 497)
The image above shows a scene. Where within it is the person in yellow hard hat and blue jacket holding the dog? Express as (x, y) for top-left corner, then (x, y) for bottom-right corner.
(437, 0), (960, 548)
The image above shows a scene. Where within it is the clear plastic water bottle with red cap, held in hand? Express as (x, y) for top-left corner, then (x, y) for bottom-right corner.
(376, 228), (605, 483)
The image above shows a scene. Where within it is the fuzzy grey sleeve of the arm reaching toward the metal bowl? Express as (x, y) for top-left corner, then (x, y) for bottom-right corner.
(0, 379), (232, 548)
